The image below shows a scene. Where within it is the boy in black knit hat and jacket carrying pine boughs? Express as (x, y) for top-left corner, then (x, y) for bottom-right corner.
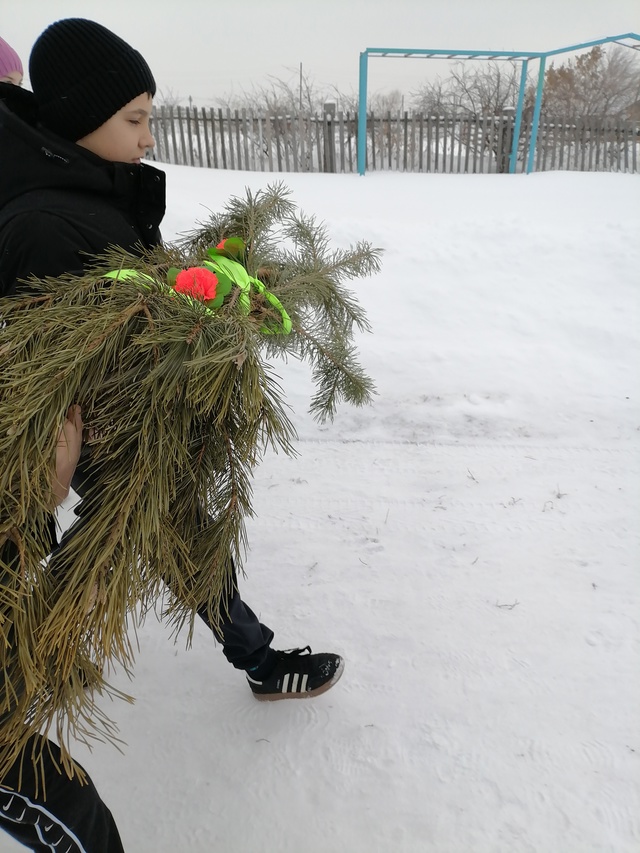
(0, 18), (343, 850)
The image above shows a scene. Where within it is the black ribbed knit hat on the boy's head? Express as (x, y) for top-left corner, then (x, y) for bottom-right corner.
(29, 18), (156, 142)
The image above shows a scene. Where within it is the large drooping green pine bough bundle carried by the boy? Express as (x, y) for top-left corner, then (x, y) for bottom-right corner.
(0, 184), (380, 779)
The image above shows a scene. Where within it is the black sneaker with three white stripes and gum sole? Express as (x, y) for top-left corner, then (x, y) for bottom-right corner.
(247, 646), (344, 702)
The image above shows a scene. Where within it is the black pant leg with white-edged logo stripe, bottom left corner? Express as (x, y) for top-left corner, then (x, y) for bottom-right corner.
(0, 736), (124, 853)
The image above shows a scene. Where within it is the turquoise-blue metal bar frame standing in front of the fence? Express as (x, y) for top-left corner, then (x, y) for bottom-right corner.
(358, 33), (640, 175)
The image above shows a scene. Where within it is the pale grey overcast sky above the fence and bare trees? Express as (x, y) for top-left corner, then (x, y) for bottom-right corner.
(5, 0), (640, 105)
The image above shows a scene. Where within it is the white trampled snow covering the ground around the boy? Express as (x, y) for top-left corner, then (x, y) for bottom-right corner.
(6, 166), (640, 853)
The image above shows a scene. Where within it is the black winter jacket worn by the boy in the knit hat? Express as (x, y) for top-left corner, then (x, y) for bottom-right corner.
(0, 84), (165, 296)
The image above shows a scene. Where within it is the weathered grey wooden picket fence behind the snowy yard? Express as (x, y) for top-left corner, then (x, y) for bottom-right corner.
(152, 106), (640, 174)
